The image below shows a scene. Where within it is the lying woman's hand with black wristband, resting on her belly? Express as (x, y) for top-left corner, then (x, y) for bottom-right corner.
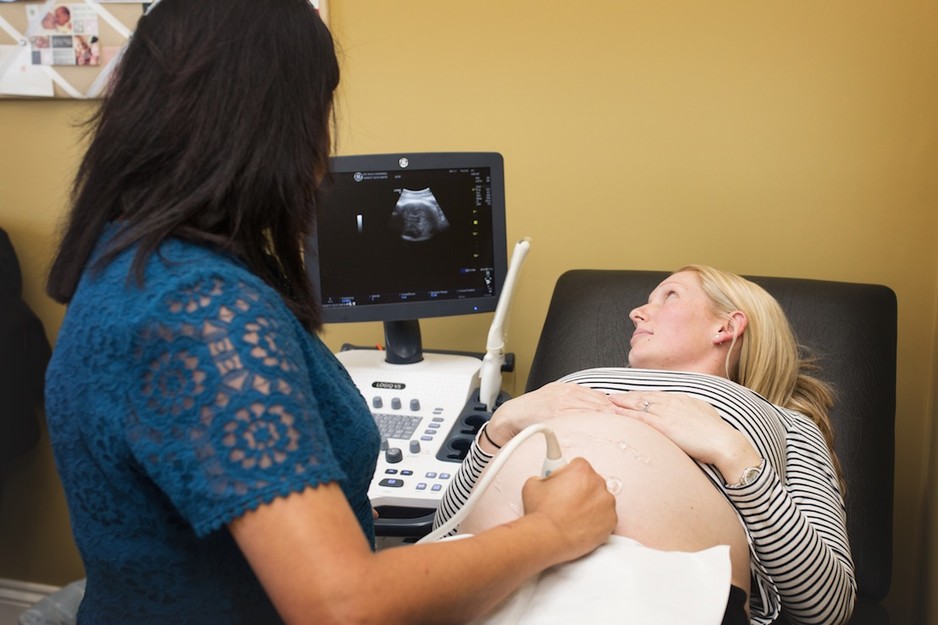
(480, 382), (624, 453)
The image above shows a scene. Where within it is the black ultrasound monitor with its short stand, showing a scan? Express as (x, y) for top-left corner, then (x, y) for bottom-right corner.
(307, 152), (508, 364)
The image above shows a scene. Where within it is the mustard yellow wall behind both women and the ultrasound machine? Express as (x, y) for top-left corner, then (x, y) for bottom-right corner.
(0, 0), (938, 623)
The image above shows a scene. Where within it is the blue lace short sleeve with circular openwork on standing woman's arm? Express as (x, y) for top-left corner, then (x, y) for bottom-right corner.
(127, 274), (344, 535)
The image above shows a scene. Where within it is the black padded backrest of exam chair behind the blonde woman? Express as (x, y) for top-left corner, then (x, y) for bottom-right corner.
(525, 269), (897, 625)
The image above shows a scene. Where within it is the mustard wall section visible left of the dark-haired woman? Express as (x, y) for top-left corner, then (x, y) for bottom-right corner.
(0, 100), (89, 585)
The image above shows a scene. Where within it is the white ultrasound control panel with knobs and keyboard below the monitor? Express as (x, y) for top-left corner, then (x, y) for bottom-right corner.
(336, 349), (500, 536)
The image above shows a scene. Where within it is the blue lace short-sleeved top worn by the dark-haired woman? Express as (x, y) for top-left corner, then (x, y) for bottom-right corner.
(46, 230), (379, 625)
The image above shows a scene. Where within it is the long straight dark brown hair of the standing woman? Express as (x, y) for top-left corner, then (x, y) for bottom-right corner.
(47, 0), (339, 330)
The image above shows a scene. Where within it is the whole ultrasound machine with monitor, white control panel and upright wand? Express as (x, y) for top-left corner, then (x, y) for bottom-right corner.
(307, 152), (529, 538)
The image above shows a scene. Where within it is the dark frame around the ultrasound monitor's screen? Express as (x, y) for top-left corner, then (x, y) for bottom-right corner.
(306, 152), (508, 323)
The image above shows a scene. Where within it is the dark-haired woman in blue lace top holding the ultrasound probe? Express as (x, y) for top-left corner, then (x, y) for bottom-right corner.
(46, 0), (616, 625)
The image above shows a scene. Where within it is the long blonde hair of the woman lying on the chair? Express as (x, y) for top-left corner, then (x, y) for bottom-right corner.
(678, 265), (843, 488)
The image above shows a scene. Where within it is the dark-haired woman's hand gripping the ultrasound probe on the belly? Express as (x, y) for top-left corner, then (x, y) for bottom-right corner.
(521, 458), (618, 562)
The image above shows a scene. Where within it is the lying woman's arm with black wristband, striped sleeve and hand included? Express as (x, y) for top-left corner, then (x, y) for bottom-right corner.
(433, 382), (623, 533)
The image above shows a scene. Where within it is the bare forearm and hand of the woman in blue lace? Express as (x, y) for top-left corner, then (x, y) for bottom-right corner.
(229, 459), (616, 625)
